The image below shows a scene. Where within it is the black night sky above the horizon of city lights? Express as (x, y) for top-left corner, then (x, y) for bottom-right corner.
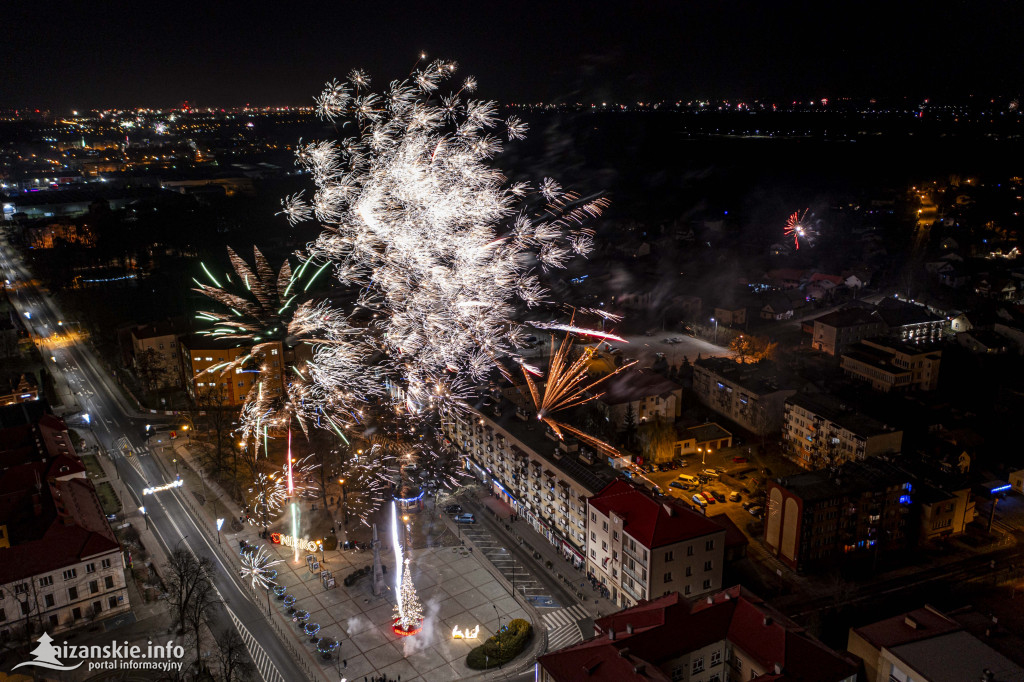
(8, 0), (1024, 112)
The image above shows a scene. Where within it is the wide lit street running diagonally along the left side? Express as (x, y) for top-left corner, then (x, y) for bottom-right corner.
(0, 239), (310, 682)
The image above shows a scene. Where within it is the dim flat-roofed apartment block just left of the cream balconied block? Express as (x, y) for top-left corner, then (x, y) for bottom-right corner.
(693, 357), (797, 435)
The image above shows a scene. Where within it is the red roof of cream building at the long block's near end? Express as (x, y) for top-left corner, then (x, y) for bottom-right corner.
(589, 479), (723, 549)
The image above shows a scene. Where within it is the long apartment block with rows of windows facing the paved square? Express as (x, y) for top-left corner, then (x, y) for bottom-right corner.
(441, 399), (616, 568)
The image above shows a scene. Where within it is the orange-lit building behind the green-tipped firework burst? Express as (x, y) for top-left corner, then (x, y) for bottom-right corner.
(180, 334), (285, 407)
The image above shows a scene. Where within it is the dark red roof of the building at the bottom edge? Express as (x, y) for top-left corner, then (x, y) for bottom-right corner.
(538, 586), (857, 682)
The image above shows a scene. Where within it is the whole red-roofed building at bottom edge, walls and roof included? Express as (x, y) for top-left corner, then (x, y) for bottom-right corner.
(534, 586), (858, 682)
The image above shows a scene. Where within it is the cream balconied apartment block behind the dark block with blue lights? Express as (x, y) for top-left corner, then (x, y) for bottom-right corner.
(782, 392), (903, 469)
